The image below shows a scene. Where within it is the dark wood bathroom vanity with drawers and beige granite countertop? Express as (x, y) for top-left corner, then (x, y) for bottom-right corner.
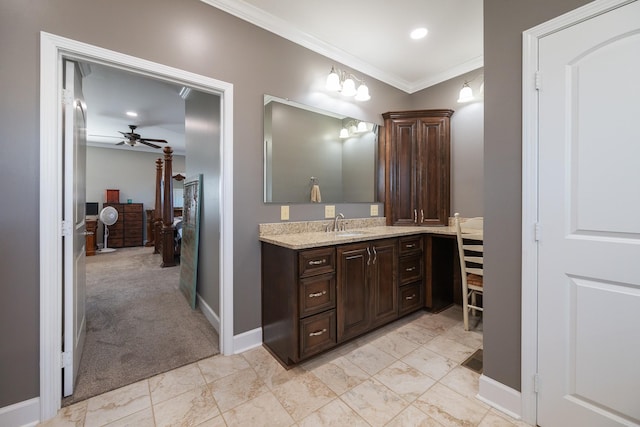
(260, 218), (460, 367)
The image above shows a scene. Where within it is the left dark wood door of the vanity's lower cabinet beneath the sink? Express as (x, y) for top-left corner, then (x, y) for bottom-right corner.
(337, 243), (371, 342)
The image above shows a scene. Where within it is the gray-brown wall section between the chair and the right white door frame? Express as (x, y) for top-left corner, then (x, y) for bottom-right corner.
(484, 0), (589, 390)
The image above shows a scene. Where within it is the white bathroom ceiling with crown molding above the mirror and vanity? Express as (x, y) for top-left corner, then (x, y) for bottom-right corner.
(201, 0), (483, 93)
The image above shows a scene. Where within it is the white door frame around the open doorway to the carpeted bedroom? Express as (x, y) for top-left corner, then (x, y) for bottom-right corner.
(39, 32), (234, 420)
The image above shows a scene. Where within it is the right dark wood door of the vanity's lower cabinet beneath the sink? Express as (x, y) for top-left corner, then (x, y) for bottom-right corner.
(369, 240), (398, 327)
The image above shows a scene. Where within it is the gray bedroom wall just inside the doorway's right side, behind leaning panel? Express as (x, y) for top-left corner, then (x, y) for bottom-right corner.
(185, 91), (221, 316)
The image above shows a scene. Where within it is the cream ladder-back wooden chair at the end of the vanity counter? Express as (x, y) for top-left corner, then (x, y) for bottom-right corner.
(454, 213), (484, 331)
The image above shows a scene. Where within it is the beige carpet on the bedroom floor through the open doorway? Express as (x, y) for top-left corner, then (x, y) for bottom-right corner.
(62, 247), (219, 406)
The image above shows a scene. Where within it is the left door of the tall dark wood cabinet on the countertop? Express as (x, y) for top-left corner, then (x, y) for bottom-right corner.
(388, 119), (419, 225)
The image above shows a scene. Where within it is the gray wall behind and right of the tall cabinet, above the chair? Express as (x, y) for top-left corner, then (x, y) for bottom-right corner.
(411, 68), (484, 218)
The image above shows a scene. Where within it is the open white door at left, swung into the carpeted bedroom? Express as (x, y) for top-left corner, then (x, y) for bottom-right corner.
(62, 60), (87, 396)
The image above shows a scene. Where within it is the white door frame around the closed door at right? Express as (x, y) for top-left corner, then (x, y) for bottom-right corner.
(521, 0), (637, 425)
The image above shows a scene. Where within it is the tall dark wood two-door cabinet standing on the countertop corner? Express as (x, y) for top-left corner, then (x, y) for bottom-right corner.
(382, 110), (453, 226)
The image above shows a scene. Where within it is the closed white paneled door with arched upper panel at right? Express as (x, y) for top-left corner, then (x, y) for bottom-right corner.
(537, 1), (640, 427)
